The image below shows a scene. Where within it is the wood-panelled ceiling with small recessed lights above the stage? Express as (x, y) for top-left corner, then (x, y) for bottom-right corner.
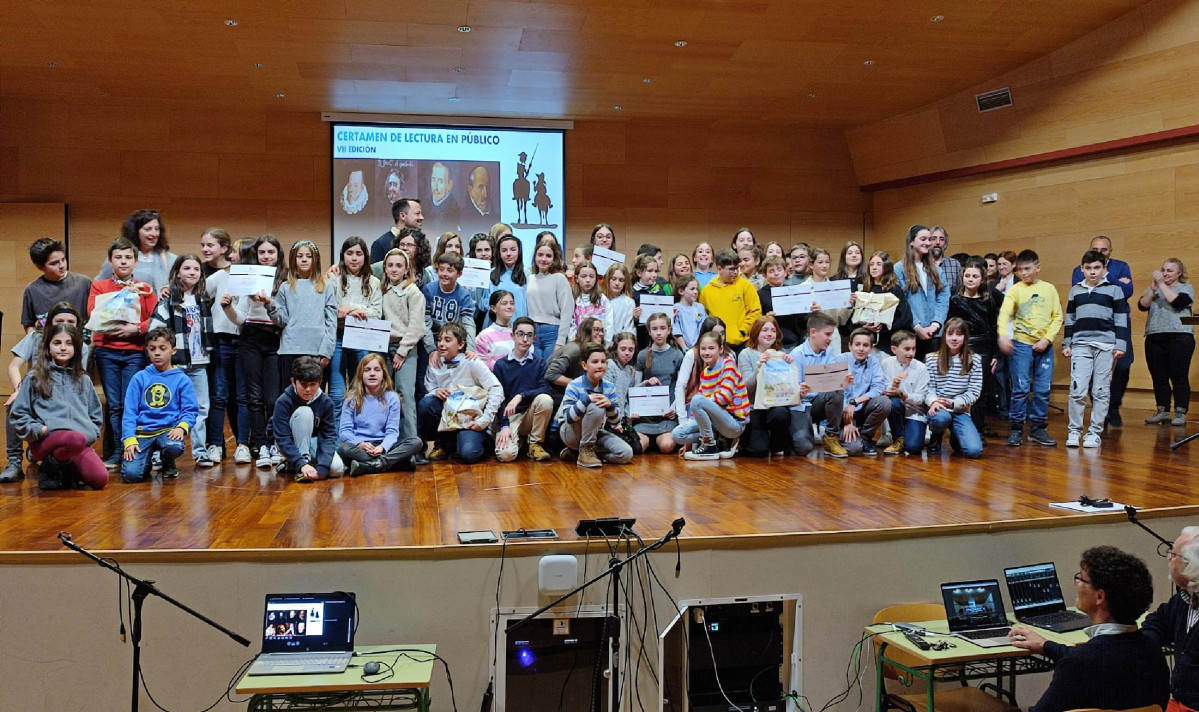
(0, 0), (1144, 127)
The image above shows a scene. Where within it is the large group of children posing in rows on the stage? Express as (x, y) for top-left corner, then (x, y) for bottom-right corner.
(0, 211), (1185, 489)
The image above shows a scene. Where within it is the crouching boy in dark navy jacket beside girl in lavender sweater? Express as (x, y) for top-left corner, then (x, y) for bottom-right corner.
(271, 356), (345, 482)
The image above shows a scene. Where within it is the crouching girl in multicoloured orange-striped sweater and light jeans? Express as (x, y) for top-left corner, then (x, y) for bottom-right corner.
(670, 332), (749, 460)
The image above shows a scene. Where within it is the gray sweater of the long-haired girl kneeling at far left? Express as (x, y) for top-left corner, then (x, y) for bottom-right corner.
(8, 366), (103, 442)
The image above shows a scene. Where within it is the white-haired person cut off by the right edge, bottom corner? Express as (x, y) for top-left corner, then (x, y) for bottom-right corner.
(1144, 526), (1199, 712)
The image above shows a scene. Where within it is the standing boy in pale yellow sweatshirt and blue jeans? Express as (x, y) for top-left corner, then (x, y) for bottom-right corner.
(999, 249), (1062, 447)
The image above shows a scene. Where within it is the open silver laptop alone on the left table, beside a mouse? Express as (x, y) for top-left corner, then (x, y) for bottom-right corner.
(249, 592), (355, 675)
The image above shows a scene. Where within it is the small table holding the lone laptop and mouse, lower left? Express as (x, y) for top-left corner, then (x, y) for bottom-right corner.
(235, 644), (438, 712)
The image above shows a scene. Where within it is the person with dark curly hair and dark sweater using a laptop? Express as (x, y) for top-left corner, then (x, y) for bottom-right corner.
(1012, 547), (1170, 712)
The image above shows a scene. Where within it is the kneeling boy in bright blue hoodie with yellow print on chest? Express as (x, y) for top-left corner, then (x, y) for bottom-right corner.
(121, 326), (200, 482)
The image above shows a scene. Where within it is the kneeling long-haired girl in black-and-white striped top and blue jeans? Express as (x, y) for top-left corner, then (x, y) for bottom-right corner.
(924, 316), (982, 459)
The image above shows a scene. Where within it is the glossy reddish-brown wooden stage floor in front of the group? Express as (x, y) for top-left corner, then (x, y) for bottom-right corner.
(0, 410), (1199, 561)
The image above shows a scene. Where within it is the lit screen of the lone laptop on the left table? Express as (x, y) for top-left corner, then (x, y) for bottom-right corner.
(263, 593), (354, 653)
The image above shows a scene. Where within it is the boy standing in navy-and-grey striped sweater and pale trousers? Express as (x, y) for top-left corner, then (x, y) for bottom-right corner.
(1061, 249), (1131, 447)
